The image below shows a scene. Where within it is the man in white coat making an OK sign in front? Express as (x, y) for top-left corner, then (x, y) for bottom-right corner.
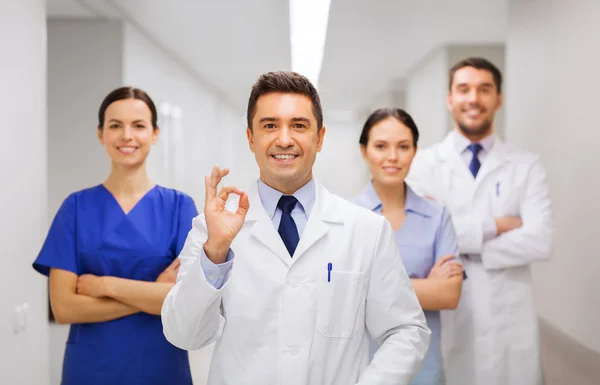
(162, 72), (430, 385)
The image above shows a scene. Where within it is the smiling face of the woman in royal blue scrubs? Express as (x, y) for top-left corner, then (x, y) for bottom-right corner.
(98, 98), (159, 168)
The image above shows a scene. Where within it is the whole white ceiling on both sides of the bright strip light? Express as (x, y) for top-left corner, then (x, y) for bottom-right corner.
(47, 0), (507, 115)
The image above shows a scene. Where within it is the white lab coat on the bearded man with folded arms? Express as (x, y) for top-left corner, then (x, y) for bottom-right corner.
(408, 132), (552, 385)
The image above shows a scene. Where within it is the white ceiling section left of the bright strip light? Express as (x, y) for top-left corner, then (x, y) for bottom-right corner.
(47, 0), (291, 109)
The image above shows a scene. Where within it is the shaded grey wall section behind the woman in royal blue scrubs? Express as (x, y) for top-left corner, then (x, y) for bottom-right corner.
(48, 19), (123, 385)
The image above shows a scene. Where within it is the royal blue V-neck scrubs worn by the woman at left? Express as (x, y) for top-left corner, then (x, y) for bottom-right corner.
(33, 185), (198, 385)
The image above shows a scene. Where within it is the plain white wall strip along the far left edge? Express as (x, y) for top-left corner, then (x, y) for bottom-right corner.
(0, 0), (49, 385)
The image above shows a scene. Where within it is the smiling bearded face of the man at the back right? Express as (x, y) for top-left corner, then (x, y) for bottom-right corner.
(447, 67), (502, 141)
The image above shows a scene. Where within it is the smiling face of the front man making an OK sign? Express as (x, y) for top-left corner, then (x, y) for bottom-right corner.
(247, 92), (325, 194)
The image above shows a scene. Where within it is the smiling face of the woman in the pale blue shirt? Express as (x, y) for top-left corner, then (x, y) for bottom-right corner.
(361, 117), (417, 186)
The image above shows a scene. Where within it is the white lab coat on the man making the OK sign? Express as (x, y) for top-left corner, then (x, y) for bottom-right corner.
(162, 178), (430, 385)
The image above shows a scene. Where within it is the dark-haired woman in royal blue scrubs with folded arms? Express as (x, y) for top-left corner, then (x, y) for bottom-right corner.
(33, 87), (197, 385)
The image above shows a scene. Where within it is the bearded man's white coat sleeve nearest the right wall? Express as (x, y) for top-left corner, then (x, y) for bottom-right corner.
(482, 159), (553, 270)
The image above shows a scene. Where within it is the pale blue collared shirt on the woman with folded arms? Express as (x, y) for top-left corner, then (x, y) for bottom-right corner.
(353, 182), (458, 385)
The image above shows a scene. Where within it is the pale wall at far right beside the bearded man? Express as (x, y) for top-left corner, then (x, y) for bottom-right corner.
(506, 0), (600, 352)
